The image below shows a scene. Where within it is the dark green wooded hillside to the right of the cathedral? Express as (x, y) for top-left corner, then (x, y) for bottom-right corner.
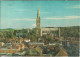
(61, 26), (79, 38)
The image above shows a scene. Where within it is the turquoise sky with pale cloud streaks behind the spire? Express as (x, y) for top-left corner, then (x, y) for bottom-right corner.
(0, 1), (80, 29)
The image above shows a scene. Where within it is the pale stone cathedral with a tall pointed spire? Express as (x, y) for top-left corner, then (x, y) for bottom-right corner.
(35, 5), (60, 38)
